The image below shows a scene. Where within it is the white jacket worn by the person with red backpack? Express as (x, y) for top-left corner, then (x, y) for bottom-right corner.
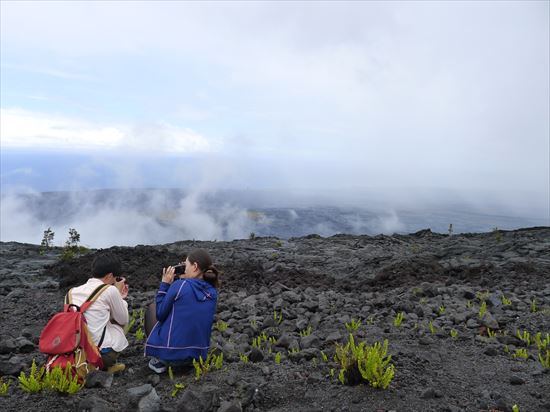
(71, 278), (128, 352)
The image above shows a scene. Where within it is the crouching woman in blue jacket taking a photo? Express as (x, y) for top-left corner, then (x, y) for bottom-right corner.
(145, 249), (219, 373)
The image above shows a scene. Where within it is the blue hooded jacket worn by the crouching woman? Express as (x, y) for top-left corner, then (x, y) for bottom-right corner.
(145, 279), (218, 361)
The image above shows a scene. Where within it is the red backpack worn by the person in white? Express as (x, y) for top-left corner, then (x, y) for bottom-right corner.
(39, 285), (109, 383)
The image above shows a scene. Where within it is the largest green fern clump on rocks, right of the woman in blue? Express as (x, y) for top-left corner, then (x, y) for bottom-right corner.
(336, 333), (395, 389)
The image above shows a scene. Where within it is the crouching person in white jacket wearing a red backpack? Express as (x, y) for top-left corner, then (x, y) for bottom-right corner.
(68, 252), (128, 373)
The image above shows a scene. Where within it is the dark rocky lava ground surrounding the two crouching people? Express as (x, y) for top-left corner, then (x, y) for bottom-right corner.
(0, 227), (550, 412)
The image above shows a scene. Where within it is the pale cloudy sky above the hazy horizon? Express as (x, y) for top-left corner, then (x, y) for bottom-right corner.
(0, 1), (550, 243)
